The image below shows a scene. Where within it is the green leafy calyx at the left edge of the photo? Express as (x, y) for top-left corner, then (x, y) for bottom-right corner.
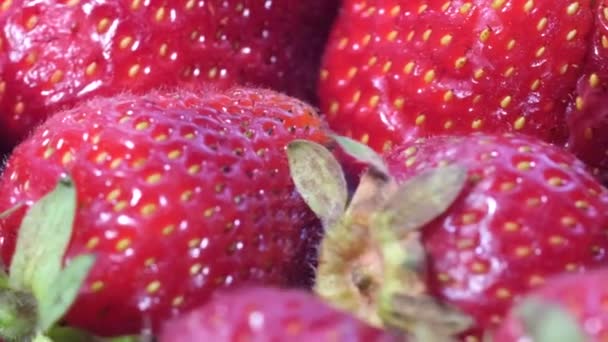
(0, 178), (95, 341)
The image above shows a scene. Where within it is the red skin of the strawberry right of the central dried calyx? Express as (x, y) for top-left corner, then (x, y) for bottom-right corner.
(387, 134), (608, 338)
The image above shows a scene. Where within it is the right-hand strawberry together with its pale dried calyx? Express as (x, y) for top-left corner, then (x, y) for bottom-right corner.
(292, 133), (608, 338)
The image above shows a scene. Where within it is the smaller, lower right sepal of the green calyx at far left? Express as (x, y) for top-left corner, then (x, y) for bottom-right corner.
(38, 255), (95, 331)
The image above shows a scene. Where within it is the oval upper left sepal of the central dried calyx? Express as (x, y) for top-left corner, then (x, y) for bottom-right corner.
(287, 140), (348, 227)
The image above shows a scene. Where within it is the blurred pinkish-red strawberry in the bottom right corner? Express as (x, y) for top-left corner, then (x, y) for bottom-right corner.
(492, 270), (608, 342)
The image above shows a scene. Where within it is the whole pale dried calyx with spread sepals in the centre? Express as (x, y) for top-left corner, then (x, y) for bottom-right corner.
(288, 137), (471, 340)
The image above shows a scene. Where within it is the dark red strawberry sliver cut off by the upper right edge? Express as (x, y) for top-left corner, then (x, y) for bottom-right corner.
(567, 0), (608, 184)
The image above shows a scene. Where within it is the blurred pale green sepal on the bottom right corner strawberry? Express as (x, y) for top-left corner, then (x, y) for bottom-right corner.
(515, 298), (587, 342)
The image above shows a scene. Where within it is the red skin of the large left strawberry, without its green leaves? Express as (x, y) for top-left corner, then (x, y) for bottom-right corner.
(0, 89), (327, 336)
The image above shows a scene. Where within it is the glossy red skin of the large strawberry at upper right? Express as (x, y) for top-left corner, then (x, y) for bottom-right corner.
(319, 0), (593, 151)
